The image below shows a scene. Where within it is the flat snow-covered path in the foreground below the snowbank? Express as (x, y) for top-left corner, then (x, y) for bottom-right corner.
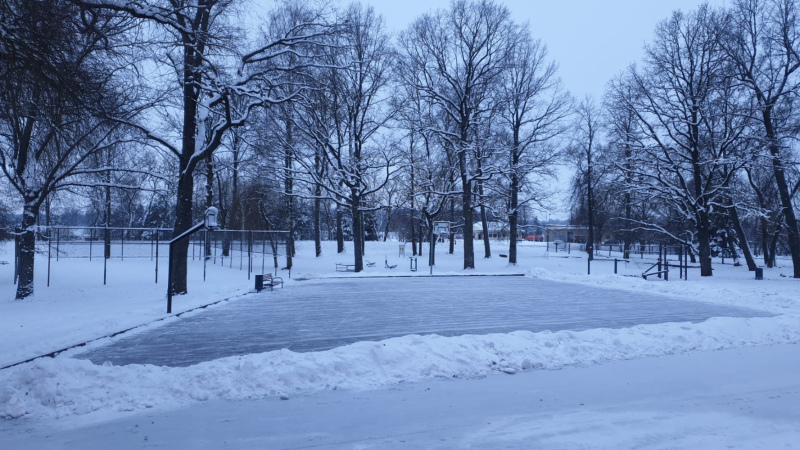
(0, 345), (800, 450)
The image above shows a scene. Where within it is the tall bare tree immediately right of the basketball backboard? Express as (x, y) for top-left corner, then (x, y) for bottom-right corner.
(400, 0), (520, 269)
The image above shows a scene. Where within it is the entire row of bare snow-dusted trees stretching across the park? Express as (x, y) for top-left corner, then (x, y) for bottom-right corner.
(0, 0), (800, 299)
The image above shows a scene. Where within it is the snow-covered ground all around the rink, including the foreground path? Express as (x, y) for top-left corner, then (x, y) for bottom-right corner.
(0, 242), (800, 448)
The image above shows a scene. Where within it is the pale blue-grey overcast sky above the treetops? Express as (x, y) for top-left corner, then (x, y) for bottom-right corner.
(366, 0), (730, 100)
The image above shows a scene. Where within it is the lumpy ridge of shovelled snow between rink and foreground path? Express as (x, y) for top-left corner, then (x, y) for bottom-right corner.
(0, 316), (800, 418)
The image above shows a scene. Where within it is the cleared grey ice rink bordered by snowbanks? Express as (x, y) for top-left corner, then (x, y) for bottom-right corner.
(78, 277), (769, 367)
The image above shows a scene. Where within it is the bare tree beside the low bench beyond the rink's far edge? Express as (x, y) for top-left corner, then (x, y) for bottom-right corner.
(298, 3), (393, 272)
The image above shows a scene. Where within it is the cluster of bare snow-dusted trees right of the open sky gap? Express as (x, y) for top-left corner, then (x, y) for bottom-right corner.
(572, 0), (800, 278)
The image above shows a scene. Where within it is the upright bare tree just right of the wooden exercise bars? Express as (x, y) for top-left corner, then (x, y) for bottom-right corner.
(618, 5), (746, 276)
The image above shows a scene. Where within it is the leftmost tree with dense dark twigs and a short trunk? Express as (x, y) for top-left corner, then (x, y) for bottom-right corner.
(0, 0), (139, 299)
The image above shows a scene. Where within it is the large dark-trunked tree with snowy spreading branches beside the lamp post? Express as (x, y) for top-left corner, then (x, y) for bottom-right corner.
(71, 0), (330, 294)
